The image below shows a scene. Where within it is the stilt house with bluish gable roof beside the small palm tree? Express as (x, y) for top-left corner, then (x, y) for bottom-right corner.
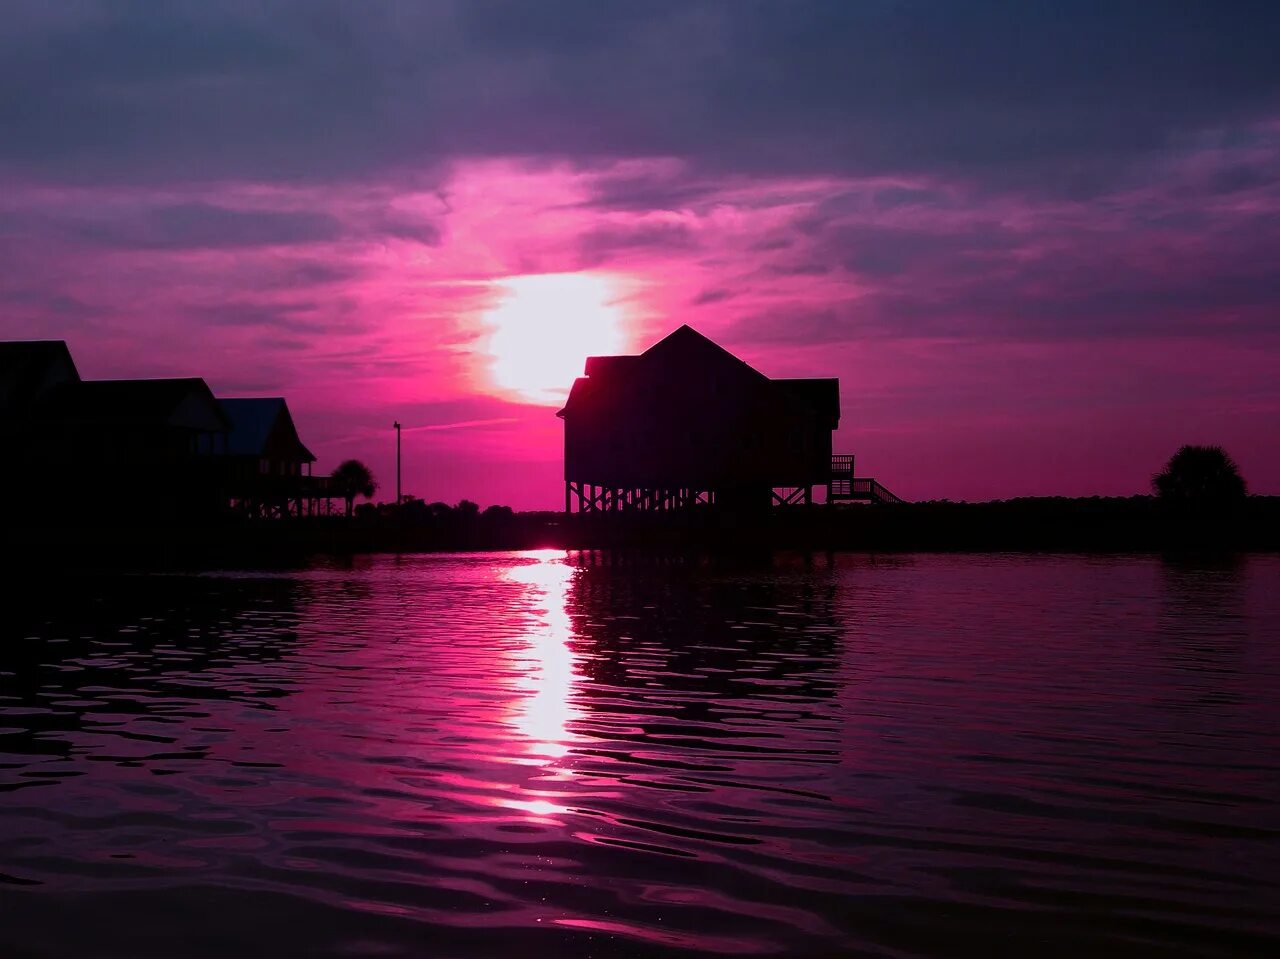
(218, 397), (329, 517)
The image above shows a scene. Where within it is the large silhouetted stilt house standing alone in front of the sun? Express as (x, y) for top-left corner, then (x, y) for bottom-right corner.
(557, 326), (897, 512)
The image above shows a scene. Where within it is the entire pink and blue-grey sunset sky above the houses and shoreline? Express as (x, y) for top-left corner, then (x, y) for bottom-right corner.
(0, 0), (1280, 508)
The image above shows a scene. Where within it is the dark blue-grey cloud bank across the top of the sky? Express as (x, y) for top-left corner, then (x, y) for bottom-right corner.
(0, 0), (1280, 192)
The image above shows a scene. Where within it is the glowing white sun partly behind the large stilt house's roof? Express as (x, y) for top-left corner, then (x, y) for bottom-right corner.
(484, 273), (625, 403)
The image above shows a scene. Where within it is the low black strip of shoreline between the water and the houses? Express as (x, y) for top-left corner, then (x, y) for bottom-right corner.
(8, 497), (1280, 570)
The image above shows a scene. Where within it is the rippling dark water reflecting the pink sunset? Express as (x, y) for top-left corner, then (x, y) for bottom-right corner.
(0, 553), (1280, 959)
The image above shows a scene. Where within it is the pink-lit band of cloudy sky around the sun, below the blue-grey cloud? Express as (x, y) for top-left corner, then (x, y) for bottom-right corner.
(0, 132), (1280, 507)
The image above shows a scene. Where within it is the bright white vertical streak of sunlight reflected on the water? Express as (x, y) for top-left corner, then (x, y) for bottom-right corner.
(506, 549), (579, 764)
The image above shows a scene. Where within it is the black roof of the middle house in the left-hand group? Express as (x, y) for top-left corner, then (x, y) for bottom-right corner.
(40, 376), (230, 430)
